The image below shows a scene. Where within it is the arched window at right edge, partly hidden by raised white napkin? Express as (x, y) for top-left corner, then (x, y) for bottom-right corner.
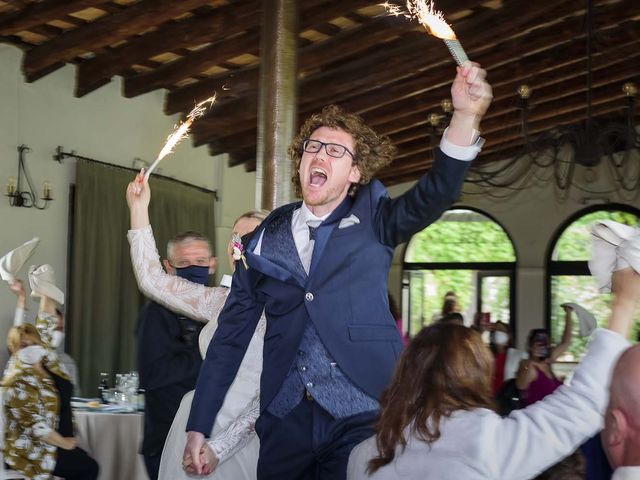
(547, 204), (640, 362)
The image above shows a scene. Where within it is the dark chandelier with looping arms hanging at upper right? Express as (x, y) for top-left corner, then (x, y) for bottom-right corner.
(465, 0), (640, 201)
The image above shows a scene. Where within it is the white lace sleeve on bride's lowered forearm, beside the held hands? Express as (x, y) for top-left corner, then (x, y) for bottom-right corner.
(207, 392), (260, 463)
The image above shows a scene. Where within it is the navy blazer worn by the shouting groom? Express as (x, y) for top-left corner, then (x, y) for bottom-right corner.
(187, 149), (470, 435)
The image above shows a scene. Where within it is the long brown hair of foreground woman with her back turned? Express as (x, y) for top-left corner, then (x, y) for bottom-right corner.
(367, 323), (494, 474)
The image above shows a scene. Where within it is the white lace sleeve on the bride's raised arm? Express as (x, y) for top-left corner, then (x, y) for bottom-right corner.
(127, 225), (226, 322)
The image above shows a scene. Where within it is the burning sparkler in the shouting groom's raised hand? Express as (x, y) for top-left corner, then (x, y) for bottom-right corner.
(382, 0), (469, 66)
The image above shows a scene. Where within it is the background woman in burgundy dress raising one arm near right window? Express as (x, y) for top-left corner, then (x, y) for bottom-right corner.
(516, 306), (573, 407)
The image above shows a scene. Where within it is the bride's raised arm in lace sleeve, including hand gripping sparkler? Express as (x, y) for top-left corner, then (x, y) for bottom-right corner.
(126, 174), (226, 322)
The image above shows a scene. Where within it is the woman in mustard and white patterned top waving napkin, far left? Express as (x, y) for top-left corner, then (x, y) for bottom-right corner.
(2, 265), (98, 480)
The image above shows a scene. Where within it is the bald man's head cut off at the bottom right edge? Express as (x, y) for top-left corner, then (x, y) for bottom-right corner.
(602, 344), (640, 480)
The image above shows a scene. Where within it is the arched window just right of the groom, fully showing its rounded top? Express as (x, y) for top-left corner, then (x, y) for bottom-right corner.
(402, 208), (516, 335)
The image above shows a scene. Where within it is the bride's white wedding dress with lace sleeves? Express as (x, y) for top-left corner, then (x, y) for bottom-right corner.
(127, 226), (266, 480)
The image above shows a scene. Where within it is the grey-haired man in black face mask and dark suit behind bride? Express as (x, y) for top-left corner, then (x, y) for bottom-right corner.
(137, 232), (215, 480)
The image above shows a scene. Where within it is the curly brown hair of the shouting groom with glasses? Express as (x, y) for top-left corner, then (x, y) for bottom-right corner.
(289, 105), (396, 197)
